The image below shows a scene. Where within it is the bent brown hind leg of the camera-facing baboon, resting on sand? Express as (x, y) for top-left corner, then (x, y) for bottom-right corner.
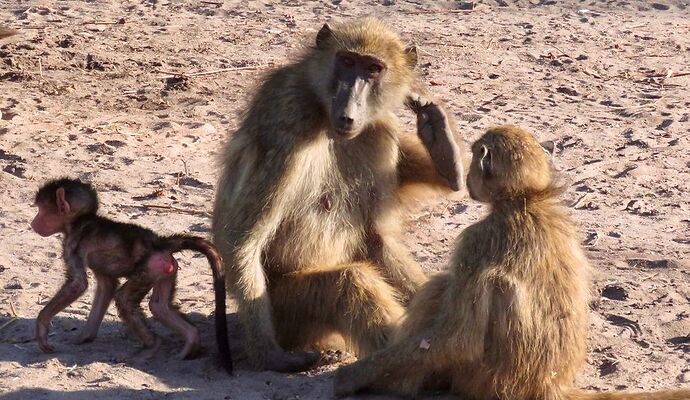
(271, 262), (404, 357)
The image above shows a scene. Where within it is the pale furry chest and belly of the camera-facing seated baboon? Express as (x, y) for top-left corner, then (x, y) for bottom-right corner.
(269, 135), (397, 272)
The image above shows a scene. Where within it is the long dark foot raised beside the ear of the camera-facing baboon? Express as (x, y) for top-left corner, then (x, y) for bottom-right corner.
(407, 93), (462, 191)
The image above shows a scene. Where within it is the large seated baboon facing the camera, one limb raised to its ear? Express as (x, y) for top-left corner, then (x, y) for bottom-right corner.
(212, 19), (462, 371)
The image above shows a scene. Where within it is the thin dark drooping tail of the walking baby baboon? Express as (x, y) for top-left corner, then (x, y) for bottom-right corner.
(166, 235), (232, 375)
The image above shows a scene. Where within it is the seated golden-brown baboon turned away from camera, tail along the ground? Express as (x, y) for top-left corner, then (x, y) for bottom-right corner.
(335, 126), (690, 400)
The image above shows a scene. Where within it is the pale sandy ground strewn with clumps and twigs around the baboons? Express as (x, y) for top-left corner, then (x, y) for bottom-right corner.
(0, 0), (690, 399)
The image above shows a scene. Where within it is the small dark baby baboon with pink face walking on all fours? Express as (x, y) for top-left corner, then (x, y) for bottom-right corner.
(31, 178), (232, 373)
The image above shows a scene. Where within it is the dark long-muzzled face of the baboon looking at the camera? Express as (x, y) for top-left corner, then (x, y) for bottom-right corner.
(330, 51), (386, 139)
